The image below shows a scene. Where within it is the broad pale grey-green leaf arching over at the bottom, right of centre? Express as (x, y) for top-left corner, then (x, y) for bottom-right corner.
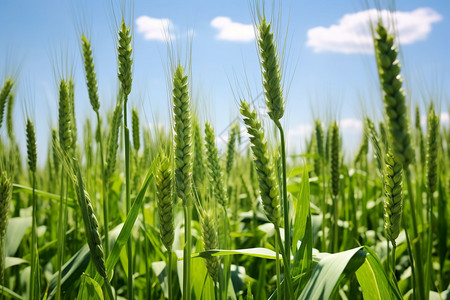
(298, 247), (367, 299)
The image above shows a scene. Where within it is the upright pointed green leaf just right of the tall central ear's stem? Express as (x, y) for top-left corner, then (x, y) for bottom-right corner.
(292, 168), (309, 253)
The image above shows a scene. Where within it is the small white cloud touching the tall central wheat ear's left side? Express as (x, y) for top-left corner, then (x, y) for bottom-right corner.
(211, 17), (255, 42)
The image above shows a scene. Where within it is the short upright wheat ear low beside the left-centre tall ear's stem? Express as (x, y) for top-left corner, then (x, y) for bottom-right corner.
(156, 156), (175, 252)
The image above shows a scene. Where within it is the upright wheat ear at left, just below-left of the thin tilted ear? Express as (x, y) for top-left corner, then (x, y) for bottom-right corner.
(58, 79), (72, 152)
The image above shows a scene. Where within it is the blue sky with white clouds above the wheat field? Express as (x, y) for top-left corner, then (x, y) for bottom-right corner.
(0, 0), (450, 164)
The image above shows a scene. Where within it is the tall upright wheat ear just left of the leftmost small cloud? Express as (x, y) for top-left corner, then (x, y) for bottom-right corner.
(117, 19), (133, 99)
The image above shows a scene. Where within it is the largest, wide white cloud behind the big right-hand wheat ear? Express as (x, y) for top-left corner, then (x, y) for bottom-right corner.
(306, 7), (442, 54)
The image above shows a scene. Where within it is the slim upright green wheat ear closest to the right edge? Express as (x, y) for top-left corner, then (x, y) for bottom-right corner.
(426, 104), (440, 195)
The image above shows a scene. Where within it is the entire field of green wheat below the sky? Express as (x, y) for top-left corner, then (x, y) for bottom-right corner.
(0, 2), (450, 300)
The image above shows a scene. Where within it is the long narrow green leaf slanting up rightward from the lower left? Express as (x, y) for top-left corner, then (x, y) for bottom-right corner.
(95, 158), (158, 284)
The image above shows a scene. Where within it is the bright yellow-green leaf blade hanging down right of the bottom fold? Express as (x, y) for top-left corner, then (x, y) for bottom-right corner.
(356, 247), (402, 300)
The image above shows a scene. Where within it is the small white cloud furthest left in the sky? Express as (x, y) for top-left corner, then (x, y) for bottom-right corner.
(136, 16), (173, 41)
